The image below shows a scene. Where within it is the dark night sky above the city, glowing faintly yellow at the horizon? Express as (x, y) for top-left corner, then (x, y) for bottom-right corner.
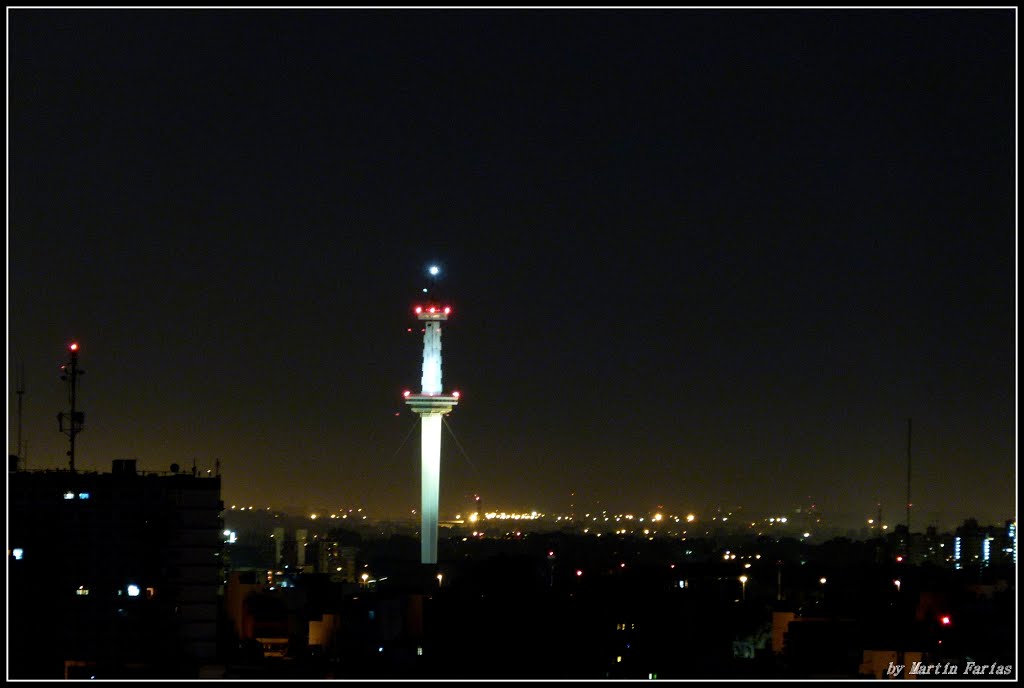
(7, 9), (1017, 526)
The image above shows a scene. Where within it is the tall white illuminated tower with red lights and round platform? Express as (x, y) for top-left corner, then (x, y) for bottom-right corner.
(404, 268), (459, 564)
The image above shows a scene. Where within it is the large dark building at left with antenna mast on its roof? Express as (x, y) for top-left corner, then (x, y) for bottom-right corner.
(7, 460), (223, 679)
